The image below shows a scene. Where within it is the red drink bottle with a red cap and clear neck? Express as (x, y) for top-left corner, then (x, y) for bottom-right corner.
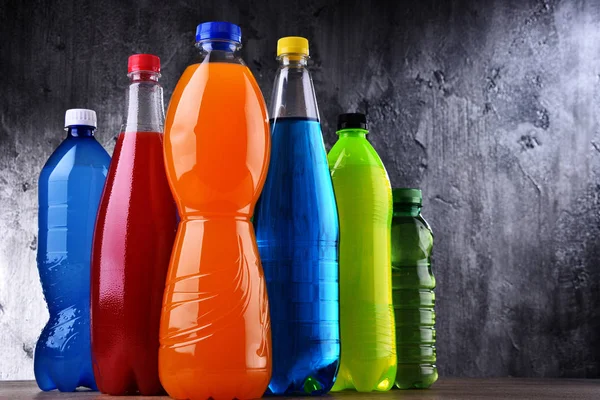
(91, 54), (177, 395)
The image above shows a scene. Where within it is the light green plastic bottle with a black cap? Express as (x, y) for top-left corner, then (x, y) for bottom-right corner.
(327, 114), (396, 392)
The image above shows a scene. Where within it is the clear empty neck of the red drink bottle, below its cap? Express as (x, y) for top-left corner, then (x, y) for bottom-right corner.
(123, 71), (165, 132)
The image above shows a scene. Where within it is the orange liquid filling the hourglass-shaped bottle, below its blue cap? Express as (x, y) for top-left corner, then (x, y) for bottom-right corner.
(159, 63), (271, 400)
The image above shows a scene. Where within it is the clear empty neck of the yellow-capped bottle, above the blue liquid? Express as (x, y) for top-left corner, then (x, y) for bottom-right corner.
(269, 54), (319, 120)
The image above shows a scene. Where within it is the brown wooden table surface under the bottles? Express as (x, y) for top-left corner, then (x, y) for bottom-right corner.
(0, 378), (600, 400)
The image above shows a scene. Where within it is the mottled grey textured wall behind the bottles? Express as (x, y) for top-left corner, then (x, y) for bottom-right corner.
(0, 0), (600, 379)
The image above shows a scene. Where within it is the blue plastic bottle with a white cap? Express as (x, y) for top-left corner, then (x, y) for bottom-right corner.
(34, 109), (110, 392)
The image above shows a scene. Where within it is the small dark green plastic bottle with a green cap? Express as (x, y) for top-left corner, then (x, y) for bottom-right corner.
(392, 189), (438, 389)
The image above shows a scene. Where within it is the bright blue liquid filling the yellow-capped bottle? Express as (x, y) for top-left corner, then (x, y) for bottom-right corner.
(254, 118), (340, 395)
